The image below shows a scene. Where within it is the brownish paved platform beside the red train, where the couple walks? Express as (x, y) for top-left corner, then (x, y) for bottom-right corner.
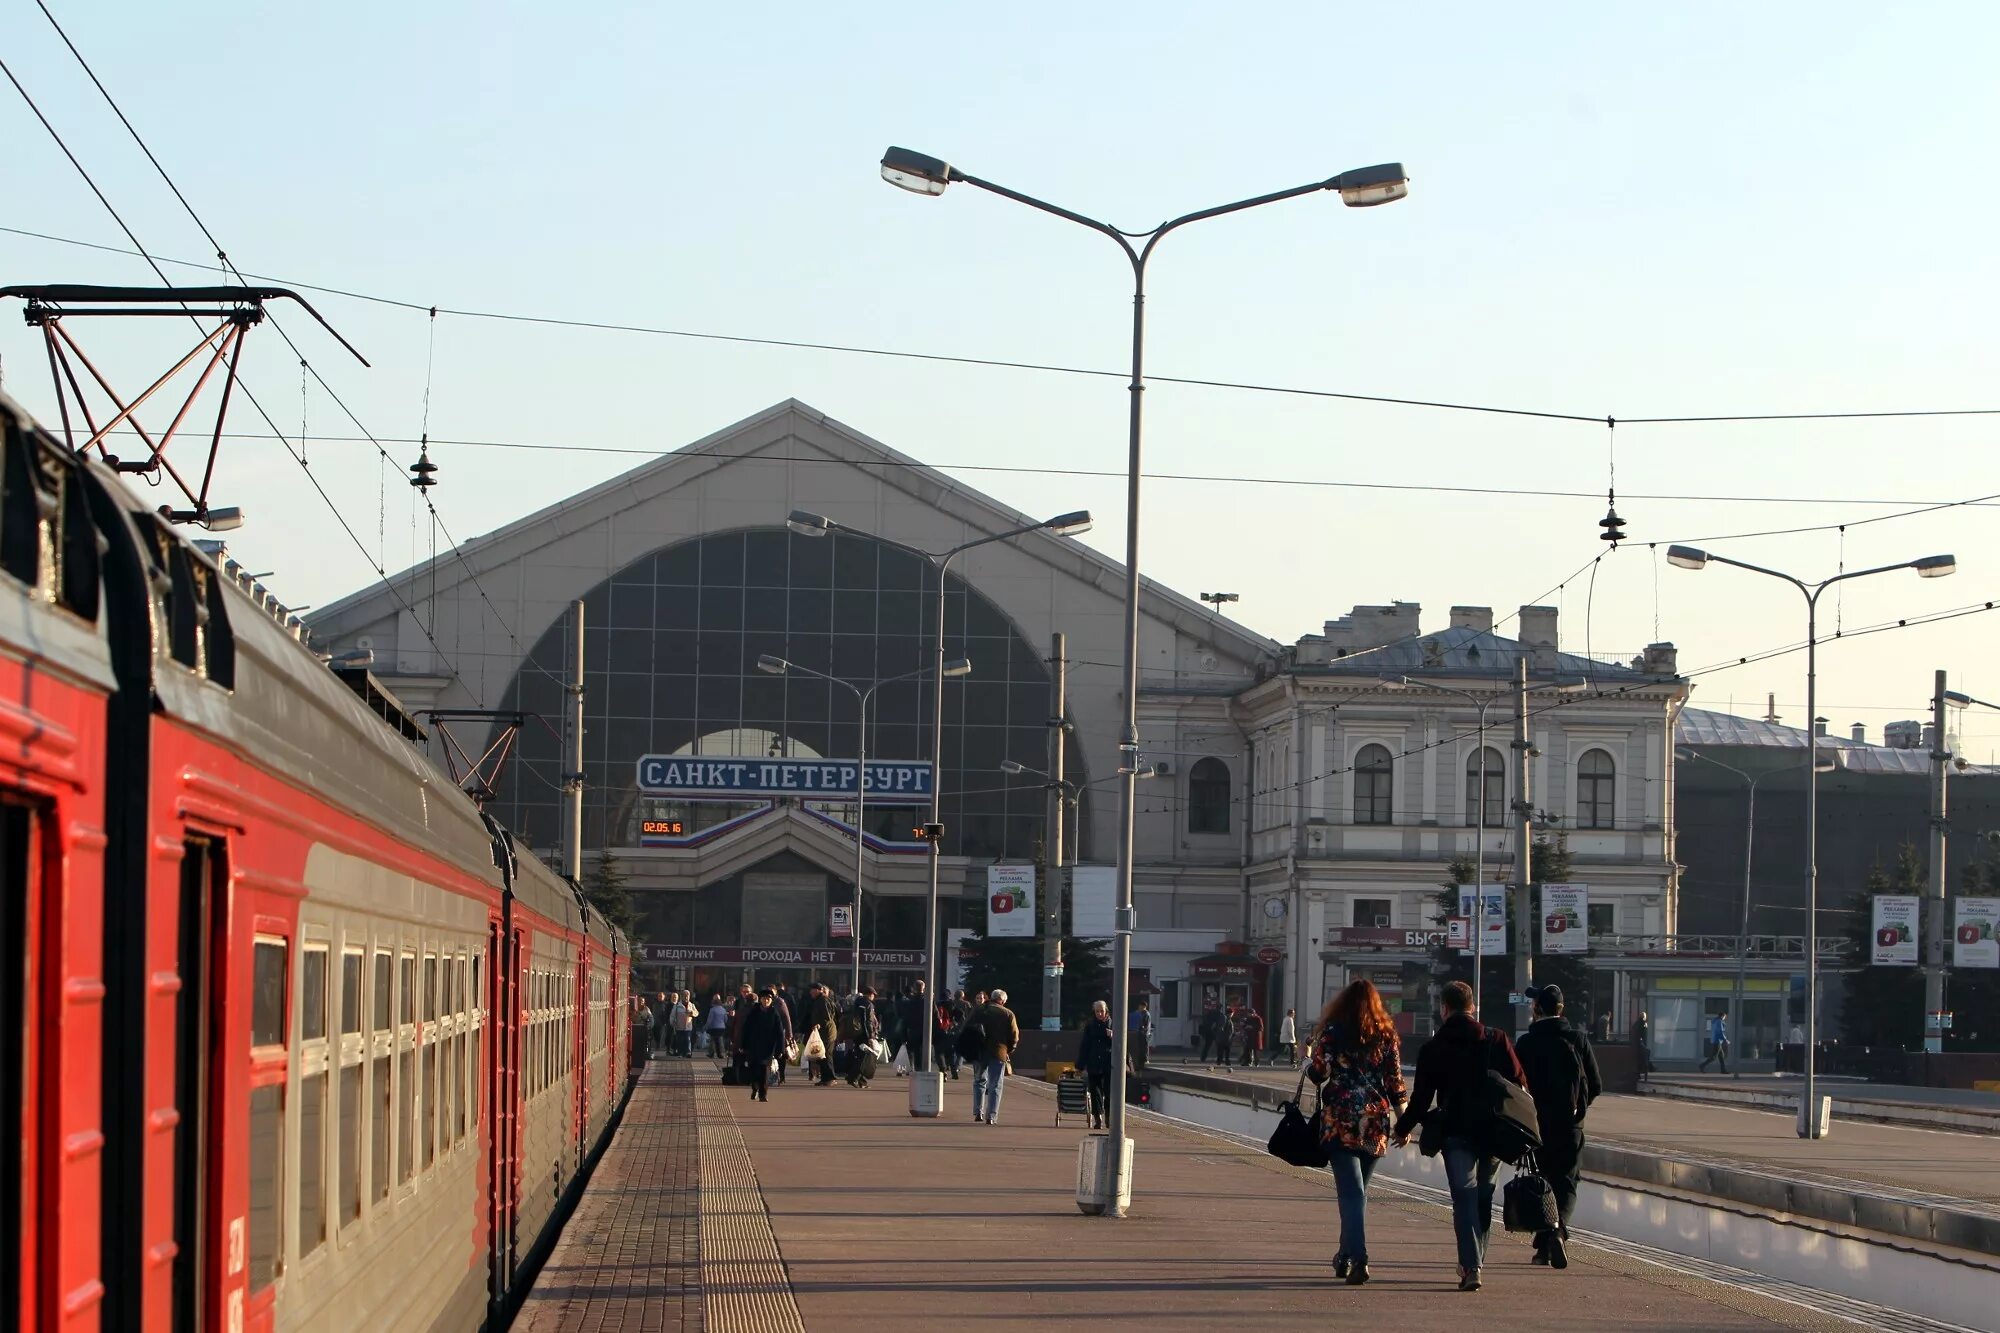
(516, 1061), (1852, 1333)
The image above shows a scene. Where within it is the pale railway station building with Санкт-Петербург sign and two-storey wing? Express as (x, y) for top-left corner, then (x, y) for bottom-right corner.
(310, 400), (1736, 1045)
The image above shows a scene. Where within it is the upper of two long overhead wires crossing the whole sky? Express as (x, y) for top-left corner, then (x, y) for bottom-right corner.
(0, 226), (2000, 426)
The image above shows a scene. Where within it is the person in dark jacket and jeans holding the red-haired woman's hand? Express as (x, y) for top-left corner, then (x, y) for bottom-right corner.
(1396, 981), (1528, 1291)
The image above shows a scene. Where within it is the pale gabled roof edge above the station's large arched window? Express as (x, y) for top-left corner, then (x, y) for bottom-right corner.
(308, 398), (1280, 658)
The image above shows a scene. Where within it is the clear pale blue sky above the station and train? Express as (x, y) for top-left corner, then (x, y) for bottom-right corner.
(0, 0), (2000, 761)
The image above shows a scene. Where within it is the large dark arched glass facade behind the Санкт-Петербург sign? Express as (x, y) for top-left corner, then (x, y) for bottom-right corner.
(490, 528), (1090, 859)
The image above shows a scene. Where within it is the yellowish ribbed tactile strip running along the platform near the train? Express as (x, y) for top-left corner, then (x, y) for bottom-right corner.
(694, 1087), (806, 1333)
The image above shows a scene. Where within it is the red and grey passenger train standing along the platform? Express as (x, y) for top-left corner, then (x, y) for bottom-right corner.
(0, 386), (630, 1333)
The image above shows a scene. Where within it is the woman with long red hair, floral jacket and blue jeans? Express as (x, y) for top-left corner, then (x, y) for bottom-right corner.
(1306, 977), (1404, 1287)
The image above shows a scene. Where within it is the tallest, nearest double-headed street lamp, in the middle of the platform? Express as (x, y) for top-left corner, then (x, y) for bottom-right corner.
(882, 148), (1410, 1217)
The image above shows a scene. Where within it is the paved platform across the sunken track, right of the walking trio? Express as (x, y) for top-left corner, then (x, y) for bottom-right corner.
(1160, 1061), (2000, 1211)
